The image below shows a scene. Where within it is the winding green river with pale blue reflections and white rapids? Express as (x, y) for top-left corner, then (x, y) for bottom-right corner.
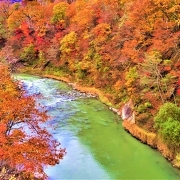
(14, 74), (180, 180)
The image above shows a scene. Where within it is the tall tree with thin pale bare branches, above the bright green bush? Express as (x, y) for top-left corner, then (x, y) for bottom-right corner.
(141, 51), (177, 104)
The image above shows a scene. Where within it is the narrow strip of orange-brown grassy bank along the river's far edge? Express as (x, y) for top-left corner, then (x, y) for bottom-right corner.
(15, 68), (180, 169)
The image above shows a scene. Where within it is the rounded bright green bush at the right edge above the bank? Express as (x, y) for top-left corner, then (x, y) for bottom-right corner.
(154, 102), (180, 147)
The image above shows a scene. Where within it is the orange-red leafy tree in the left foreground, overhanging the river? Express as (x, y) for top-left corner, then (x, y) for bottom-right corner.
(0, 64), (64, 178)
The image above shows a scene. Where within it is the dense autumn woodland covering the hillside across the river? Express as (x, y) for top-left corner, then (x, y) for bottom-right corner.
(0, 0), (180, 178)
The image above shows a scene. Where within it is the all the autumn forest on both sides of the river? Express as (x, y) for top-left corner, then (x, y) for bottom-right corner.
(0, 0), (180, 179)
